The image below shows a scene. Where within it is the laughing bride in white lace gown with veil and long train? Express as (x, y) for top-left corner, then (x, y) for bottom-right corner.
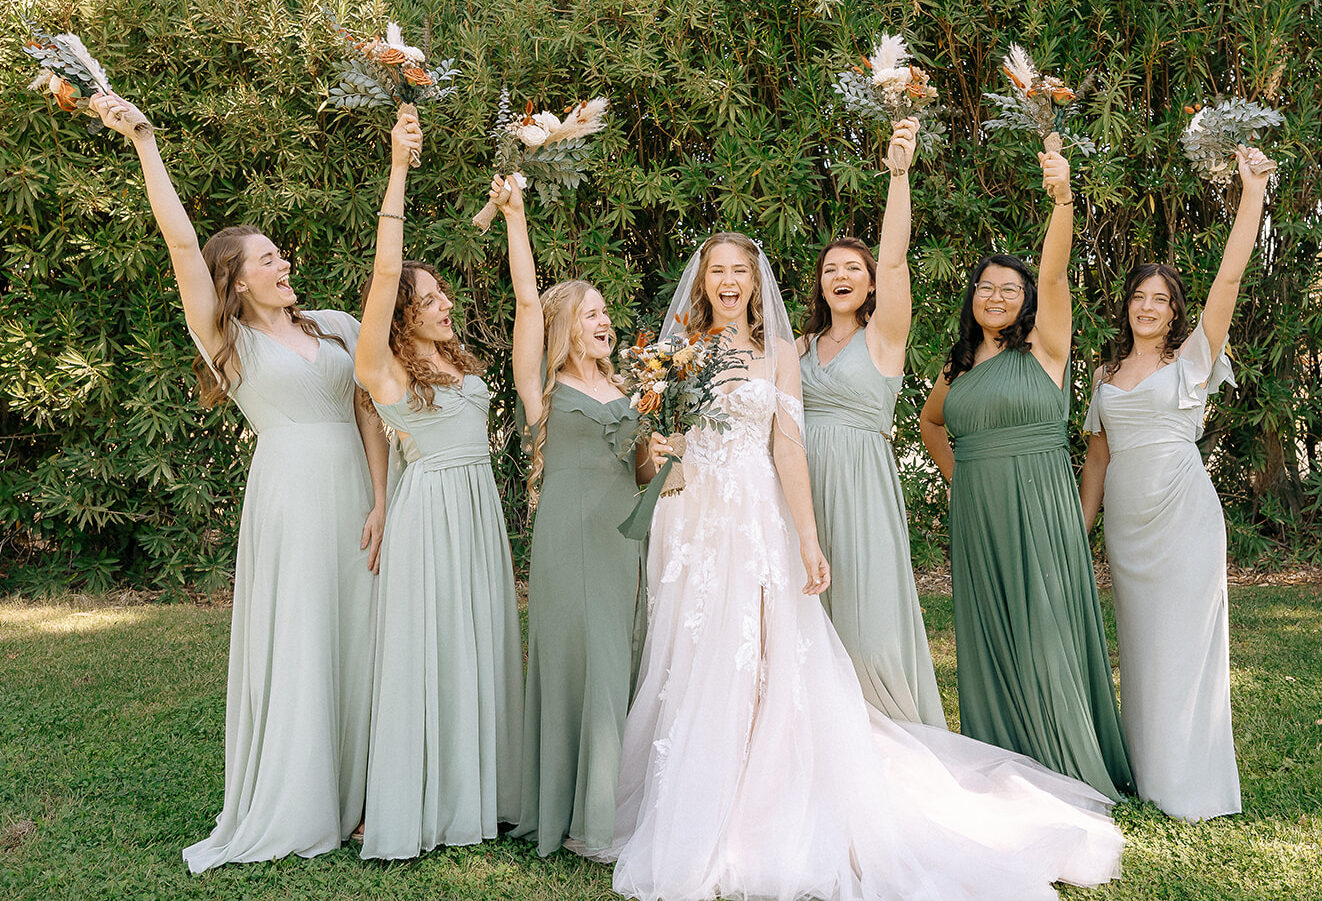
(611, 233), (1124, 901)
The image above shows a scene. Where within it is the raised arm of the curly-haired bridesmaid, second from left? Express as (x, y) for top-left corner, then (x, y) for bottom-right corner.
(353, 112), (422, 403)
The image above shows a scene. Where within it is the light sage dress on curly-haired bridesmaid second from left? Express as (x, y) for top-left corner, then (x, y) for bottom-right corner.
(362, 375), (524, 859)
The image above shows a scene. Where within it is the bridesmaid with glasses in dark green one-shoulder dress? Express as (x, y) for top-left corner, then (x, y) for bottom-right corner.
(920, 153), (1133, 801)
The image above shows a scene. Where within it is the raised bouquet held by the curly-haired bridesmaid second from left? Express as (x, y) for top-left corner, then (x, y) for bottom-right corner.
(321, 20), (459, 168)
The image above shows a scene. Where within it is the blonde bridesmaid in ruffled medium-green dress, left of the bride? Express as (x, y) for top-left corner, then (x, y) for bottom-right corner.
(492, 178), (652, 857)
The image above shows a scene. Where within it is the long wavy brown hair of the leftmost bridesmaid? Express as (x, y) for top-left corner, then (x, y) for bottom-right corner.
(193, 225), (349, 408)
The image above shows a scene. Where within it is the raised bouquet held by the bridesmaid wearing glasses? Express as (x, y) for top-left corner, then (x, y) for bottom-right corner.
(982, 44), (1097, 156)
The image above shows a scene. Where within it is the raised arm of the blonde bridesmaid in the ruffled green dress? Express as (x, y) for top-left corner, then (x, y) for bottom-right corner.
(490, 176), (546, 424)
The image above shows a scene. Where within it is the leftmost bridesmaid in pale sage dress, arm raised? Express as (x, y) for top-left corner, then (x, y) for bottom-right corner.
(91, 94), (386, 873)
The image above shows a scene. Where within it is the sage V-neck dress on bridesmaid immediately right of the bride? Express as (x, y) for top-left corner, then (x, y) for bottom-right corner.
(801, 329), (945, 728)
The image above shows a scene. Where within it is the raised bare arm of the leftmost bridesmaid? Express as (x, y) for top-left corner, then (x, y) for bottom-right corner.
(89, 92), (221, 355)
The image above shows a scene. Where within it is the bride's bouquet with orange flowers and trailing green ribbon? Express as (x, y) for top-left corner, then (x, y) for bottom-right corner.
(620, 322), (748, 539)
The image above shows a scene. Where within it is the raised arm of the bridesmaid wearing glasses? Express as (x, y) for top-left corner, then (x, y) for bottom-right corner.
(1032, 153), (1073, 386)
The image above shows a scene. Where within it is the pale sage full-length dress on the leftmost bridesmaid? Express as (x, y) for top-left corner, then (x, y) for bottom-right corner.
(184, 310), (375, 873)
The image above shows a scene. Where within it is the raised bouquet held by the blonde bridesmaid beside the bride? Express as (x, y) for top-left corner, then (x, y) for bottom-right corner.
(473, 89), (609, 231)
